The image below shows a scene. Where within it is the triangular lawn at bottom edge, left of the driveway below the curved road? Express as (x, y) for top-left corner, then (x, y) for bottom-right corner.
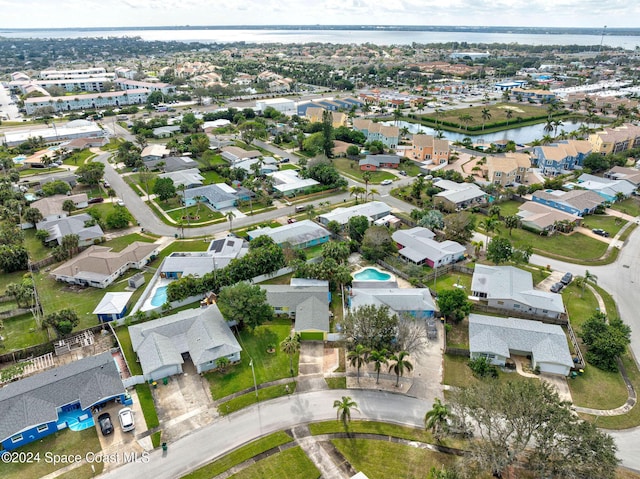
(229, 447), (320, 479)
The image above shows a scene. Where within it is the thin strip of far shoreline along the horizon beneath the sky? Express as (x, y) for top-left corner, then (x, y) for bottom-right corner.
(0, 25), (640, 36)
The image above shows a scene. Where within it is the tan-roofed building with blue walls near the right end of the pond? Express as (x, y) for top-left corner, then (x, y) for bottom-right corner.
(533, 140), (592, 176)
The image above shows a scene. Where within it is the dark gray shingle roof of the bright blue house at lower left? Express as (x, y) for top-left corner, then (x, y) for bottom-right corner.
(0, 352), (125, 440)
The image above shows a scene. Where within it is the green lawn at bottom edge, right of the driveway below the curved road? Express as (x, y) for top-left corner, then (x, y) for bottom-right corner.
(331, 439), (455, 479)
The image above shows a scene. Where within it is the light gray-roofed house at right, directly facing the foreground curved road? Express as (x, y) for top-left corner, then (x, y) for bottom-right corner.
(469, 313), (574, 376)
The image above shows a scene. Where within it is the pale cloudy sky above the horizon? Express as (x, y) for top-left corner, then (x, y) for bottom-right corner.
(0, 0), (640, 29)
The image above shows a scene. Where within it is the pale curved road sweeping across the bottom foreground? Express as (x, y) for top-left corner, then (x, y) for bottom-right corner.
(100, 390), (433, 479)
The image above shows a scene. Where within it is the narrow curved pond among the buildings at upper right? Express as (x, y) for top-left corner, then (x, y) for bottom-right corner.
(382, 121), (582, 145)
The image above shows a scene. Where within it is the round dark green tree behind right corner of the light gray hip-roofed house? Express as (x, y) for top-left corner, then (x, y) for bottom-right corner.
(218, 281), (273, 329)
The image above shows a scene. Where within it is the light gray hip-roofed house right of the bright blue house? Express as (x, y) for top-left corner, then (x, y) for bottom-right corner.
(129, 304), (242, 381)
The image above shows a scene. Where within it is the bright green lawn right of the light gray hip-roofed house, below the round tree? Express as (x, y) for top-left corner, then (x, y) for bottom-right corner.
(205, 318), (298, 399)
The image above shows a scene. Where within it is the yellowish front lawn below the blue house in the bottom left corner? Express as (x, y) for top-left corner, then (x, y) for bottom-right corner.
(0, 427), (103, 479)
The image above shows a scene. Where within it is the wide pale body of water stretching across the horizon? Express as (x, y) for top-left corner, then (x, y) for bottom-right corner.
(0, 28), (640, 50)
